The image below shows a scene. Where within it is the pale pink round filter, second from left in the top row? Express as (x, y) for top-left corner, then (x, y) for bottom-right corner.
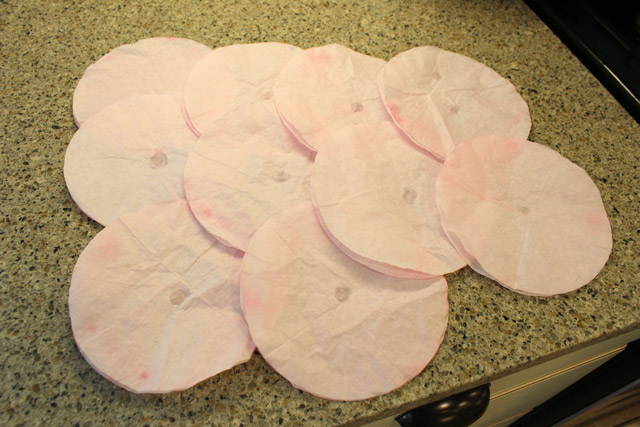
(184, 43), (302, 134)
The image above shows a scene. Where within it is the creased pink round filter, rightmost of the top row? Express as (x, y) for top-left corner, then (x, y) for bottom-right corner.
(380, 46), (531, 159)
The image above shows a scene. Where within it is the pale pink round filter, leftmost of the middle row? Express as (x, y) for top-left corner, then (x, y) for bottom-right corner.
(64, 93), (197, 225)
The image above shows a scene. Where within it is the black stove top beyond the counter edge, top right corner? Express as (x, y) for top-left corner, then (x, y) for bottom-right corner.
(525, 0), (640, 123)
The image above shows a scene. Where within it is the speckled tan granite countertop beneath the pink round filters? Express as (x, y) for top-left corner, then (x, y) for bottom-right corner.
(0, 0), (640, 425)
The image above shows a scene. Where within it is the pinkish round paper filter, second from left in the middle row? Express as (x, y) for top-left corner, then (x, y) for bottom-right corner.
(184, 102), (313, 251)
